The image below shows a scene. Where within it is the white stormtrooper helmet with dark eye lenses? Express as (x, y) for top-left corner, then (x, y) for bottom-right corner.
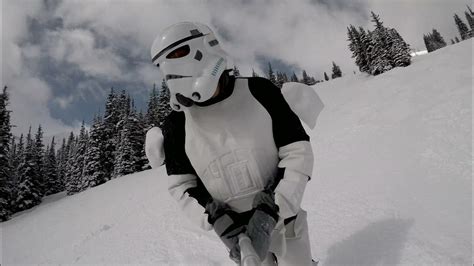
(151, 22), (232, 111)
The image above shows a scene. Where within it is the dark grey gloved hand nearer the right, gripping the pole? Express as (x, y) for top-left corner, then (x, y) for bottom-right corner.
(247, 190), (279, 261)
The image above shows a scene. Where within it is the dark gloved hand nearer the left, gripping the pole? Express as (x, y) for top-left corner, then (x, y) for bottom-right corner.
(206, 200), (246, 263)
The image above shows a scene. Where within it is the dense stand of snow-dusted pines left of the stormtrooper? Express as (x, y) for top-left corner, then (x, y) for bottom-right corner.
(0, 81), (171, 221)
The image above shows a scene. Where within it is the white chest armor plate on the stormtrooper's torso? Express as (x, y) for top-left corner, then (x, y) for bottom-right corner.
(181, 79), (278, 211)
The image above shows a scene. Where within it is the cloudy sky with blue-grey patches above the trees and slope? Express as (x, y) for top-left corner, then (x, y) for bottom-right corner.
(0, 0), (470, 135)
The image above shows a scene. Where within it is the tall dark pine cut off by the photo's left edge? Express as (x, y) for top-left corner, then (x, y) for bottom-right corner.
(0, 86), (14, 222)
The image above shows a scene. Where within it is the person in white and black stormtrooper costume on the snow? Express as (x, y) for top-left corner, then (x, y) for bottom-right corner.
(146, 22), (314, 265)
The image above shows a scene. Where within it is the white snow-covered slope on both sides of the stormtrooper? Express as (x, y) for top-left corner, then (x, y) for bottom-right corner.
(0, 41), (473, 265)
